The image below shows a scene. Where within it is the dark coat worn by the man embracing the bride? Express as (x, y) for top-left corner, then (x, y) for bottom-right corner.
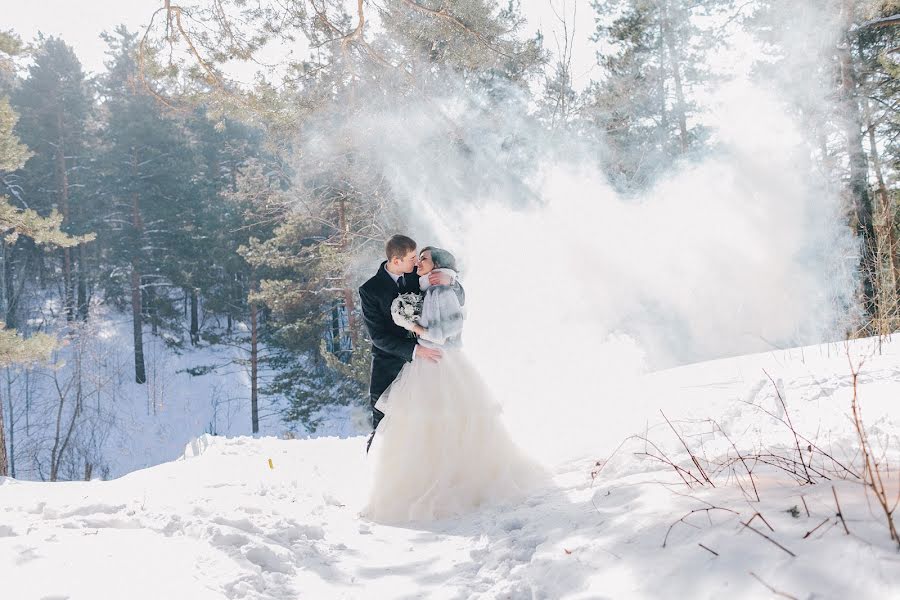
(359, 261), (465, 427)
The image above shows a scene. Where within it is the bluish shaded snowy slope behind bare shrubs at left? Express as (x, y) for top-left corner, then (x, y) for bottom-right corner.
(3, 307), (365, 480)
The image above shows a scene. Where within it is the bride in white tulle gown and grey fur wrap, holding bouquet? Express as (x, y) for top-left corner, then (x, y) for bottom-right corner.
(362, 247), (543, 523)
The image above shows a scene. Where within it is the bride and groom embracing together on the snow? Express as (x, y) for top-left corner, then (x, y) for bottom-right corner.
(359, 235), (543, 523)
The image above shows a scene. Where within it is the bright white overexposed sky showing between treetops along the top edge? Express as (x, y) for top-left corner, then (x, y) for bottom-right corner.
(8, 0), (595, 88)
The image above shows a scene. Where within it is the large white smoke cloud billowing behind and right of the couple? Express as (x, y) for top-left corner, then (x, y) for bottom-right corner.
(328, 3), (857, 458)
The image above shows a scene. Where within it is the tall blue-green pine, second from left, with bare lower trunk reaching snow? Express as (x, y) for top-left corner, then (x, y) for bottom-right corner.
(101, 28), (198, 383)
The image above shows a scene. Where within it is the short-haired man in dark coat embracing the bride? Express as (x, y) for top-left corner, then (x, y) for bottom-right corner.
(359, 235), (465, 452)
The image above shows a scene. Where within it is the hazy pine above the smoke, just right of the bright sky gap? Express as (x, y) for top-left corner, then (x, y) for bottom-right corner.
(586, 0), (730, 189)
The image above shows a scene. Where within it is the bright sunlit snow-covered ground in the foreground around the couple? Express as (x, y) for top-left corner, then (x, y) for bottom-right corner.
(0, 340), (900, 600)
